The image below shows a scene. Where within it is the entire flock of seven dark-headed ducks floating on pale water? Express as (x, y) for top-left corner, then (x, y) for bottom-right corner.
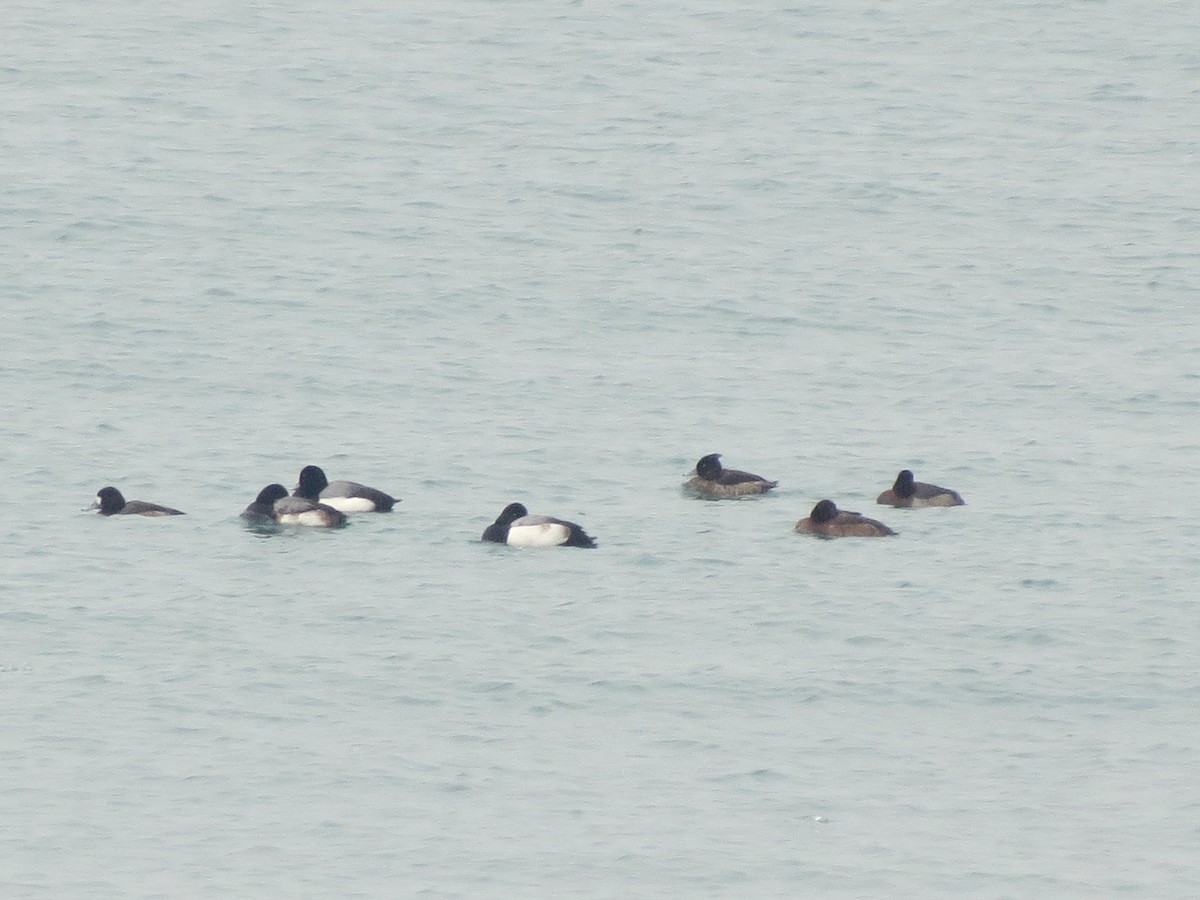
(90, 454), (964, 547)
